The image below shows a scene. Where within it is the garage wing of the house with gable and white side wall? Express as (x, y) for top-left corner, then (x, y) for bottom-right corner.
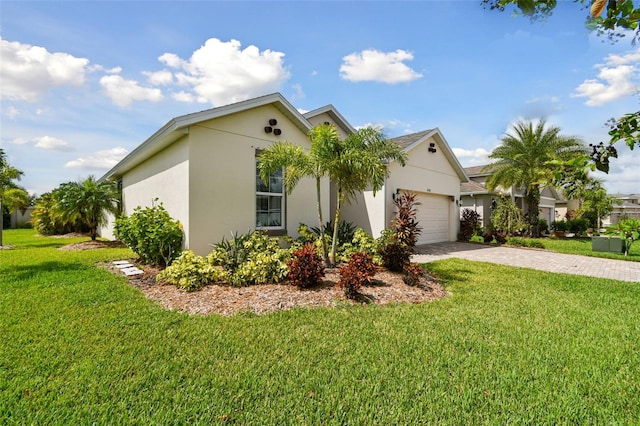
(342, 128), (468, 244)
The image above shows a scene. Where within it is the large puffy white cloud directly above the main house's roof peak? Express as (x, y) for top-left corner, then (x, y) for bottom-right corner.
(158, 38), (289, 106)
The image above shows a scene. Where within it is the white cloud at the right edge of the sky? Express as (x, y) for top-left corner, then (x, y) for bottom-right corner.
(573, 49), (640, 106)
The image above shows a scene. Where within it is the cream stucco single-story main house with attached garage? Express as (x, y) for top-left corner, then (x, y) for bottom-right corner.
(100, 93), (466, 255)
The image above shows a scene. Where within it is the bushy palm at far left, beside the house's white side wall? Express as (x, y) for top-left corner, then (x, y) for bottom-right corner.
(53, 176), (120, 240)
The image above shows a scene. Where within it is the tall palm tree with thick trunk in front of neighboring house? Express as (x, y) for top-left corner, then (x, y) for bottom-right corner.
(486, 120), (586, 236)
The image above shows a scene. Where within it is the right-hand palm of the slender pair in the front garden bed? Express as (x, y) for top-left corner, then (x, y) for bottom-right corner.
(326, 127), (407, 265)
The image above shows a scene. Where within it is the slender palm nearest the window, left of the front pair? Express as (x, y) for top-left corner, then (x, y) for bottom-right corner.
(258, 124), (340, 265)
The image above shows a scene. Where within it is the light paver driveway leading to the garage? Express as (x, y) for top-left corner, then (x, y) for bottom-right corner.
(411, 242), (640, 282)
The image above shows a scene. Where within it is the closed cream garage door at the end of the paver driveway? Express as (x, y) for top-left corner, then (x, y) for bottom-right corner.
(416, 193), (452, 244)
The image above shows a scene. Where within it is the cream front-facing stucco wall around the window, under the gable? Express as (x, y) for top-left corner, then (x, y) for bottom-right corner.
(189, 105), (329, 254)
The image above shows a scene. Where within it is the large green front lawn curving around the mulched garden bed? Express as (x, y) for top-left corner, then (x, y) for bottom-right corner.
(0, 230), (640, 425)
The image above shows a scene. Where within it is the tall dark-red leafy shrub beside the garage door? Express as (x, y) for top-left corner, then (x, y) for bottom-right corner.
(380, 192), (421, 272)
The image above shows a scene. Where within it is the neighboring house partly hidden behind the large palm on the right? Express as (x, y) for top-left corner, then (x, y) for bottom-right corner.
(460, 165), (572, 227)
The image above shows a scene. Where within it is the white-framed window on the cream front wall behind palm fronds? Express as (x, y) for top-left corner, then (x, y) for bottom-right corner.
(256, 161), (284, 229)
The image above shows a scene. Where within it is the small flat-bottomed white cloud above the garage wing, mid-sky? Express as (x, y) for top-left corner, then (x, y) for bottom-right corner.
(340, 49), (422, 84)
